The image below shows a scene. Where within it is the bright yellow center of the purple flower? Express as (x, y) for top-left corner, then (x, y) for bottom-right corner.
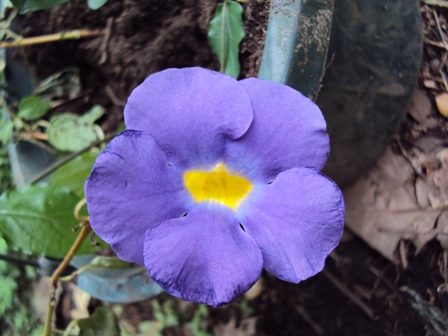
(184, 163), (252, 209)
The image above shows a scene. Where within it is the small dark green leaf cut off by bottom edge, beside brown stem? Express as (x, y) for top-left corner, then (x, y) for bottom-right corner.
(78, 307), (121, 336)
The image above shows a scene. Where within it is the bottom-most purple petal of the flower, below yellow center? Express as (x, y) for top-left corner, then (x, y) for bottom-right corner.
(145, 203), (263, 307)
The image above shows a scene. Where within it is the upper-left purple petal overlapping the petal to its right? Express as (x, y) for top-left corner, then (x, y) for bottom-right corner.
(124, 68), (253, 168)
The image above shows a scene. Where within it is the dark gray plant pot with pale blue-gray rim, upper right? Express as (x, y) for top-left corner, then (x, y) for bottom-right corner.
(259, 0), (422, 186)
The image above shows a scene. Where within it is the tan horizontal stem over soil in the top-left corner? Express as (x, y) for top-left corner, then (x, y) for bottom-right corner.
(0, 29), (103, 48)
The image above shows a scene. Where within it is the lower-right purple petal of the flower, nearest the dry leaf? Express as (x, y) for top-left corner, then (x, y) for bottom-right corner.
(237, 168), (344, 283)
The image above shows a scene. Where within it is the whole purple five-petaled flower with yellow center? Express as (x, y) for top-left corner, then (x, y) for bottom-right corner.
(85, 68), (344, 306)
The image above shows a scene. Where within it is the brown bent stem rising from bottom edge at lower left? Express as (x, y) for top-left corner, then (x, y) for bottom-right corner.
(44, 221), (92, 336)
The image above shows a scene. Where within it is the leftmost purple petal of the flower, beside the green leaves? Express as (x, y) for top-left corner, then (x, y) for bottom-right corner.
(85, 131), (192, 264)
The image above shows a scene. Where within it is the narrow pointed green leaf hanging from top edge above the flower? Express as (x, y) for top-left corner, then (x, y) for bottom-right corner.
(208, 0), (244, 78)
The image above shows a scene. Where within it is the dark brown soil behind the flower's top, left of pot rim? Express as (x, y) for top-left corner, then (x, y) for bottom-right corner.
(21, 0), (269, 132)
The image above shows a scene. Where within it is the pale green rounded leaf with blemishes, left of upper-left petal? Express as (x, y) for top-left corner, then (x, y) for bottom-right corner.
(47, 105), (104, 152)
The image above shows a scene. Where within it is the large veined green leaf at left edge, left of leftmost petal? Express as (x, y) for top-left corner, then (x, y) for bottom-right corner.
(0, 184), (96, 258)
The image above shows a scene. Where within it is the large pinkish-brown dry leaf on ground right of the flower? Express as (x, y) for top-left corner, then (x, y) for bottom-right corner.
(344, 148), (448, 262)
